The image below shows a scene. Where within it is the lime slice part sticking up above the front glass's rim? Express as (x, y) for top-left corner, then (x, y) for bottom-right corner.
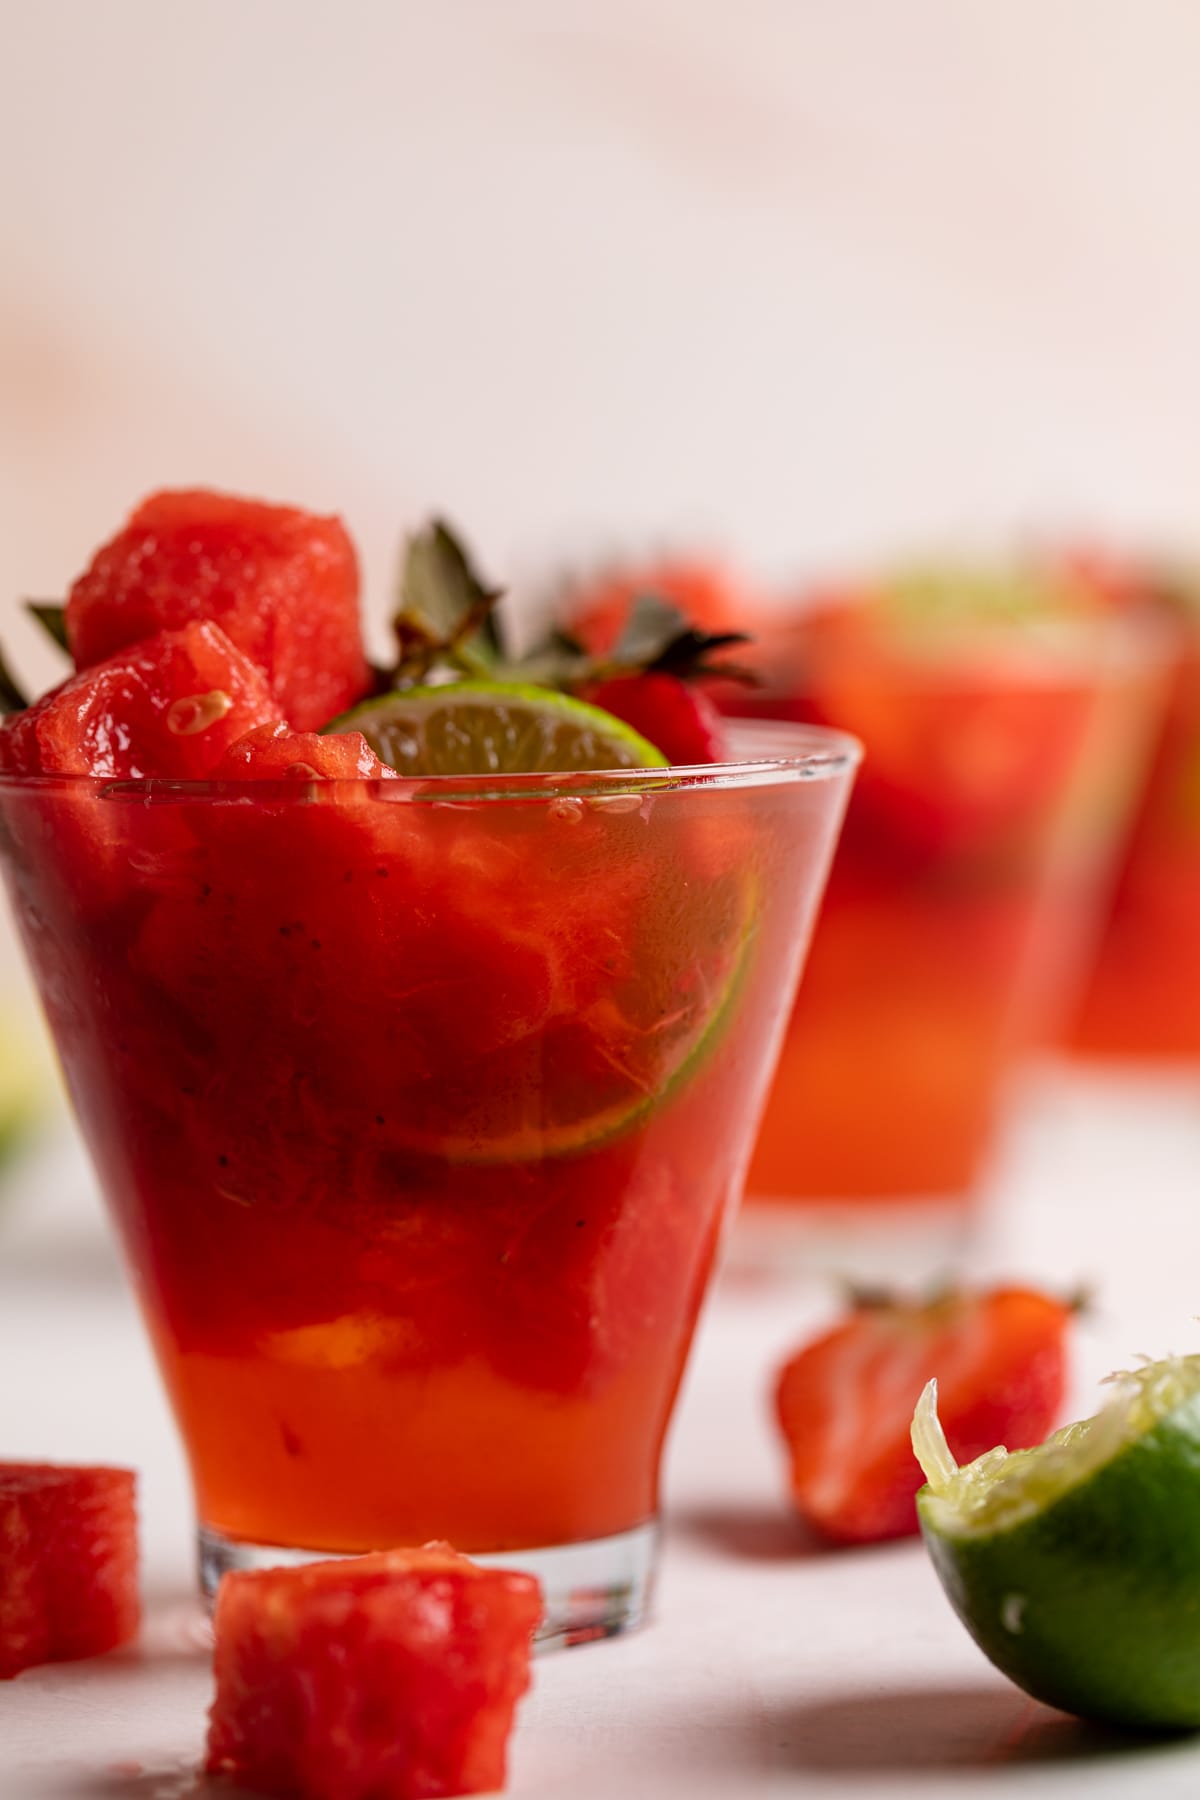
(324, 680), (667, 776)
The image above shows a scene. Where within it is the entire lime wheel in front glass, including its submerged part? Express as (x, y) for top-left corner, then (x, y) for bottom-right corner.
(329, 680), (759, 1165)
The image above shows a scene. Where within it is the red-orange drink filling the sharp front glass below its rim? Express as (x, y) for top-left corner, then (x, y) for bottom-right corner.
(0, 731), (853, 1629)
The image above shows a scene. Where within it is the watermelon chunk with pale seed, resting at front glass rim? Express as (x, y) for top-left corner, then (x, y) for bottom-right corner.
(0, 623), (277, 781)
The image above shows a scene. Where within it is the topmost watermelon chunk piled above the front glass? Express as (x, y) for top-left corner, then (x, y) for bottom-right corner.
(67, 490), (371, 731)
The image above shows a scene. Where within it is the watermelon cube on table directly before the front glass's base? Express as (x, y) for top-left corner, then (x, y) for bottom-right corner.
(205, 1544), (542, 1800)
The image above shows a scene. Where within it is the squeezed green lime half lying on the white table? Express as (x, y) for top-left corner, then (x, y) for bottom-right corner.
(912, 1355), (1200, 1730)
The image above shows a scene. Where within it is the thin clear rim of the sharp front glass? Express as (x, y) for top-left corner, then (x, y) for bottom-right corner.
(0, 718), (864, 805)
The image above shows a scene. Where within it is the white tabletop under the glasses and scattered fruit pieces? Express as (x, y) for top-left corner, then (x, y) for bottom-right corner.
(0, 1075), (1200, 1800)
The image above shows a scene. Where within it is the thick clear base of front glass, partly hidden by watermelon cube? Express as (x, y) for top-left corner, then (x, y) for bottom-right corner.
(196, 1521), (658, 1651)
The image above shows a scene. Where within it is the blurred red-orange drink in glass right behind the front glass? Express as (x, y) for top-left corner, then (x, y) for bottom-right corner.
(721, 594), (1162, 1228)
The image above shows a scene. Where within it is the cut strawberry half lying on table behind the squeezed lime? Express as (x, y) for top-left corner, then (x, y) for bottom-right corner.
(775, 1287), (1076, 1544)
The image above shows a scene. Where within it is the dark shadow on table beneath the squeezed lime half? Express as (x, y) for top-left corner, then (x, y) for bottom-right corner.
(772, 1687), (1193, 1782)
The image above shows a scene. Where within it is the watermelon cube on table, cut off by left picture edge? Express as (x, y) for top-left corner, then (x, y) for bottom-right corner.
(0, 1463), (140, 1679)
